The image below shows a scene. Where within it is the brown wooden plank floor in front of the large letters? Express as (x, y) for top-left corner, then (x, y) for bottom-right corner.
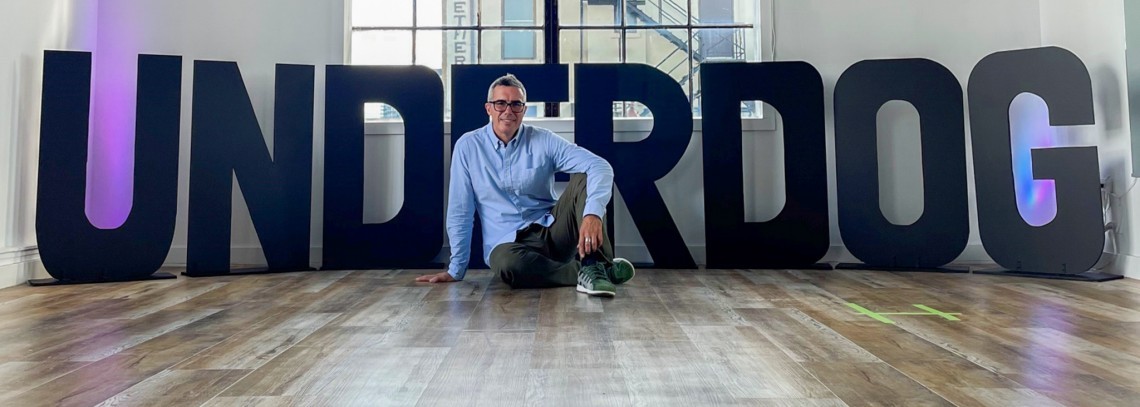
(0, 266), (1140, 406)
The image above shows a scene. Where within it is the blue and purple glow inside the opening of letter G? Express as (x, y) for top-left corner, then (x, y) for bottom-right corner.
(1009, 93), (1057, 226)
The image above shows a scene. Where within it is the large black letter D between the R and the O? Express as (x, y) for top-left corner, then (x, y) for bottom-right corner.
(701, 62), (831, 268)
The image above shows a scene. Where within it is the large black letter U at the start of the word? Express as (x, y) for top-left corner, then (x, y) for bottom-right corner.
(35, 51), (182, 283)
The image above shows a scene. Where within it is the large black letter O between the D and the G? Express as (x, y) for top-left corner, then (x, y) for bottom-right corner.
(836, 59), (970, 268)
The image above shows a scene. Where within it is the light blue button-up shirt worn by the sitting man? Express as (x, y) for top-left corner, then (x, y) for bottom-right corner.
(447, 124), (613, 279)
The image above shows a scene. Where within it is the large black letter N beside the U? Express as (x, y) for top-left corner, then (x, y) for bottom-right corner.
(186, 60), (314, 276)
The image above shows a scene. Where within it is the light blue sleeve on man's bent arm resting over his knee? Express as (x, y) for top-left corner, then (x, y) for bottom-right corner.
(546, 132), (613, 218)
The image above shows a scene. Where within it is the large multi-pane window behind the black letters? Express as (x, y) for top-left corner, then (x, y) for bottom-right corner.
(349, 0), (772, 120)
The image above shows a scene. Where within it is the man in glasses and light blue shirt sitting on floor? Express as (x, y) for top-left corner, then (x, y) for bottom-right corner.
(416, 74), (634, 296)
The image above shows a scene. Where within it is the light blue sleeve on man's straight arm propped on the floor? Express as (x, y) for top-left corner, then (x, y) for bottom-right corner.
(447, 139), (475, 280)
